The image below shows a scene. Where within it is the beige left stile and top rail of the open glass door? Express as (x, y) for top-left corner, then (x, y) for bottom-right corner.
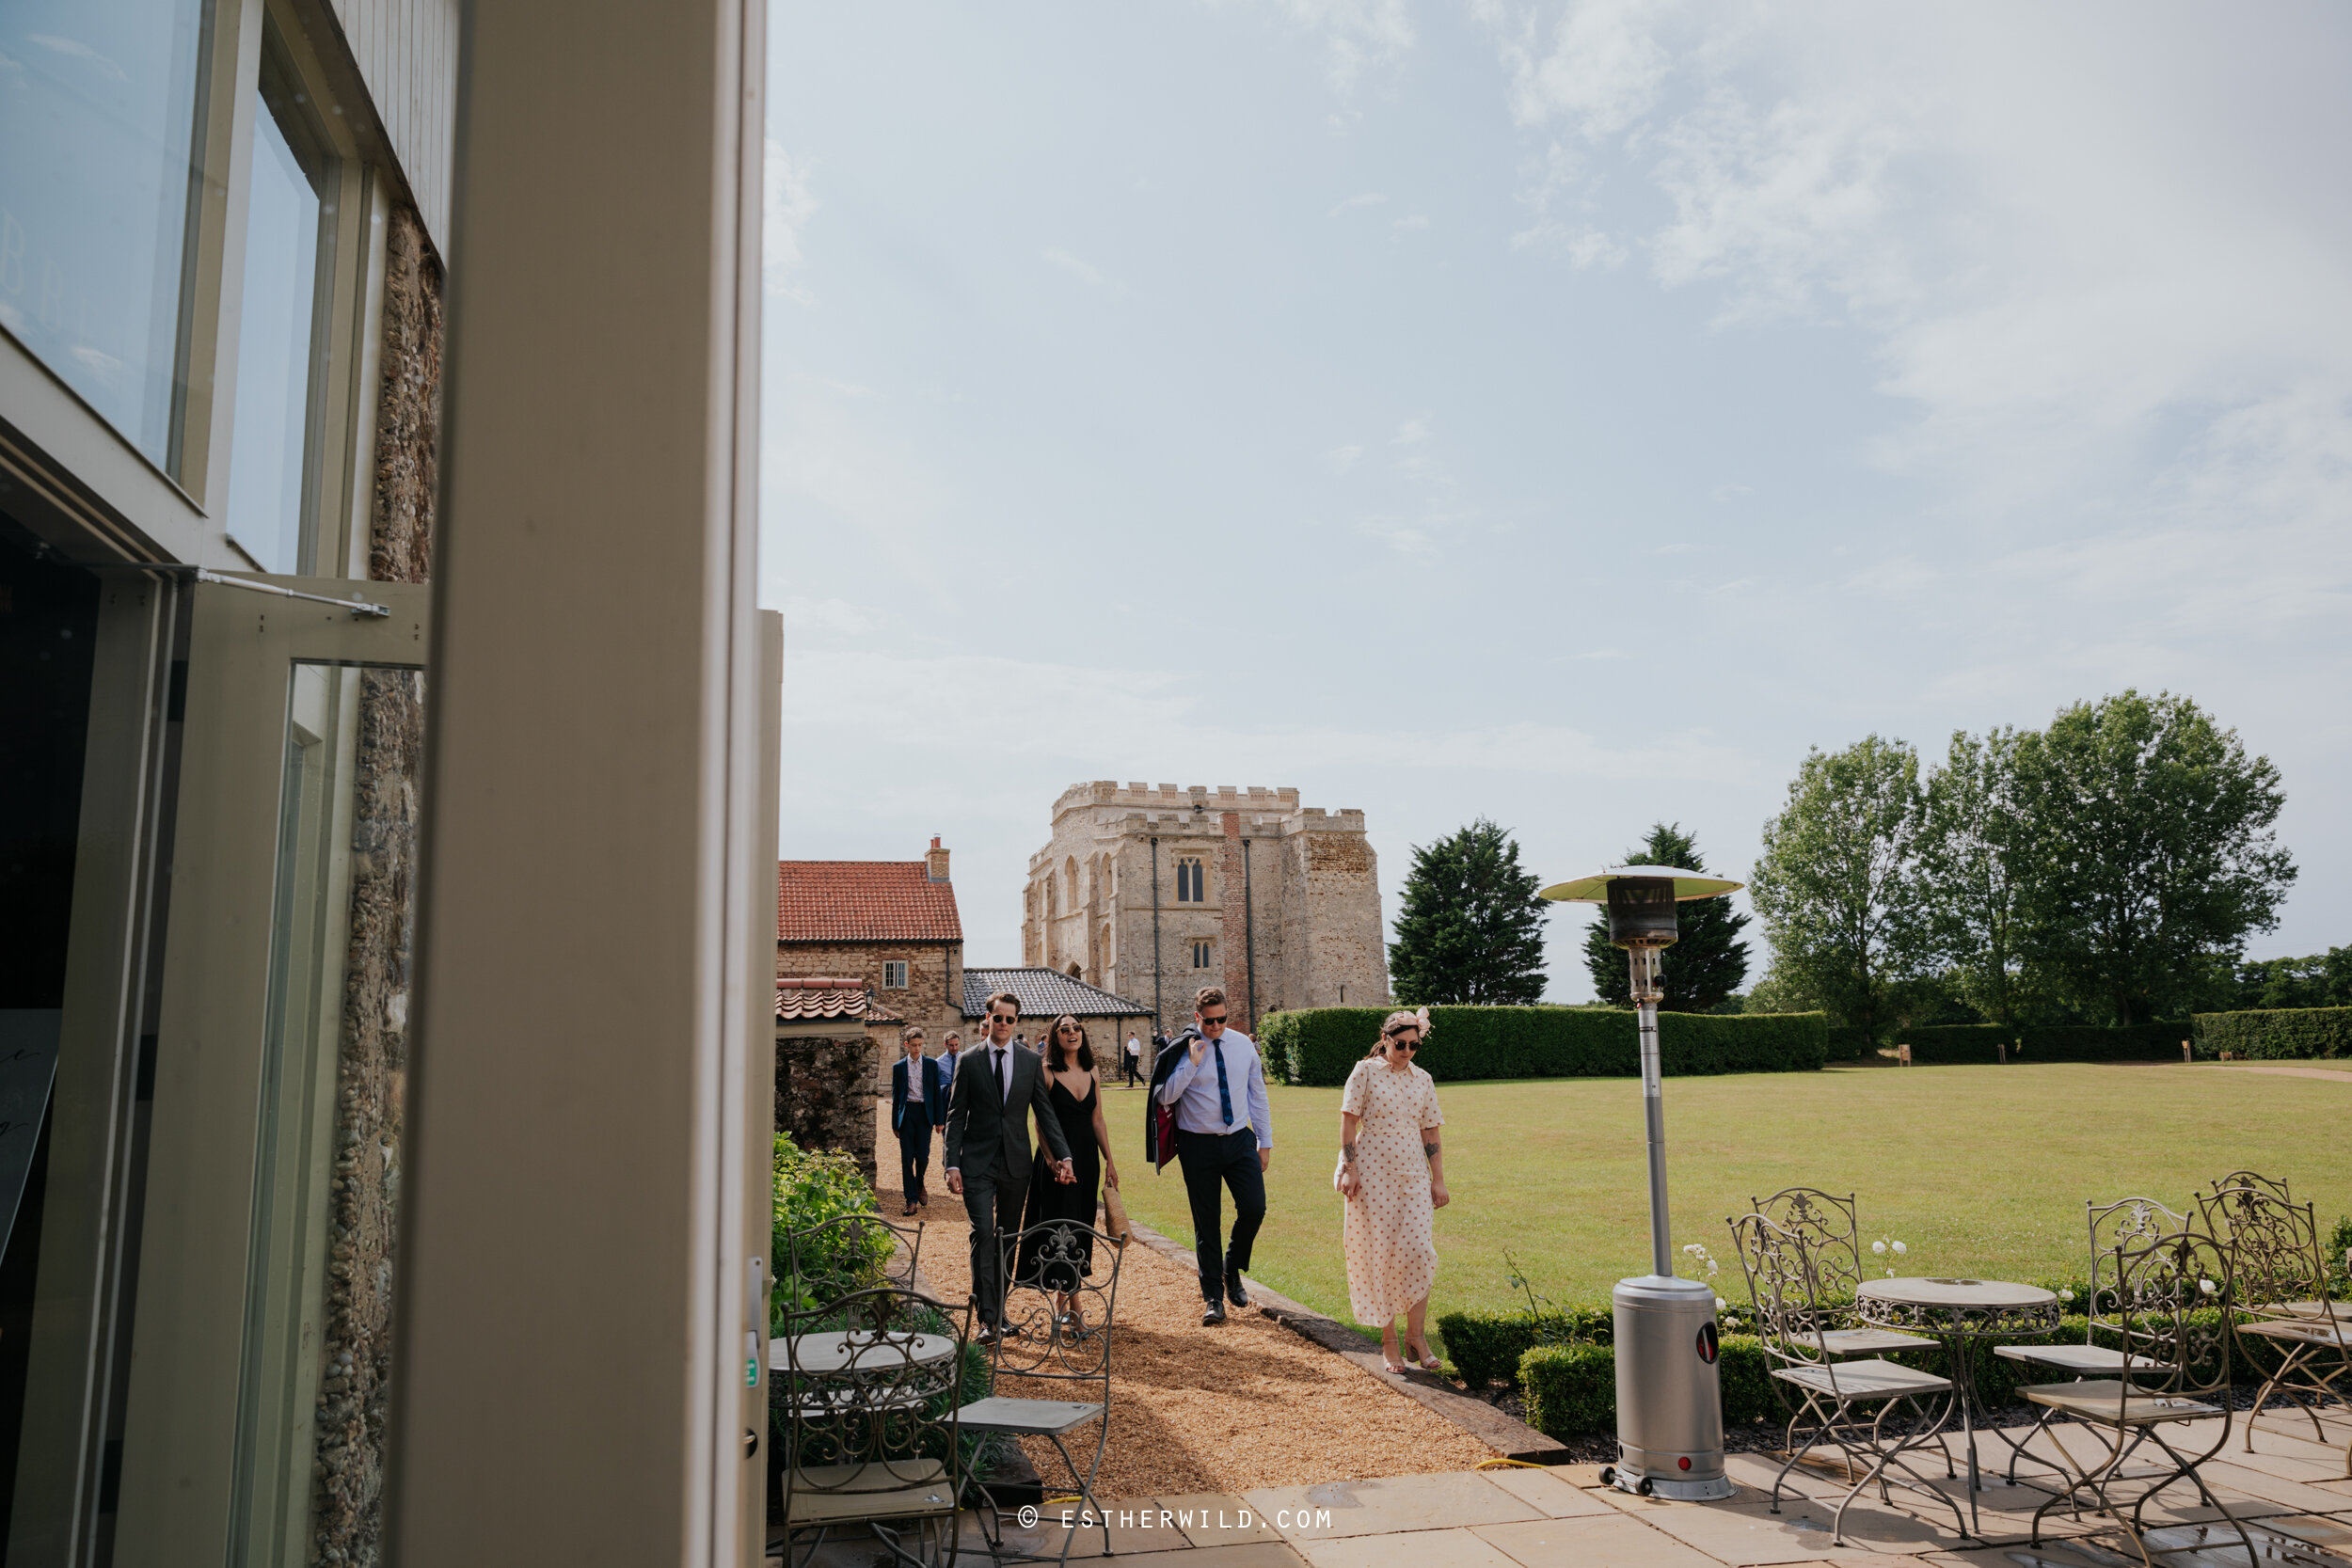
(116, 574), (431, 1563)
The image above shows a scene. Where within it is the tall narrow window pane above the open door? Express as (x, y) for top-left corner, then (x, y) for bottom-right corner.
(229, 71), (320, 571)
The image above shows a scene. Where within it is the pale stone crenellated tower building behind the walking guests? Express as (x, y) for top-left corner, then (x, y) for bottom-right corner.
(1021, 781), (1388, 1032)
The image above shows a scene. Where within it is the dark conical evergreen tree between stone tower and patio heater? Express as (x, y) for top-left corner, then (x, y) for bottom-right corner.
(1388, 818), (1550, 1006)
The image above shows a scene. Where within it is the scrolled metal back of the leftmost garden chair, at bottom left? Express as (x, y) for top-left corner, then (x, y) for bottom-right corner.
(770, 1286), (972, 1507)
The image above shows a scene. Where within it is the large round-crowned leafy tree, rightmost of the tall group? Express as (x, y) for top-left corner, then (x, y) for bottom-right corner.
(2018, 691), (2296, 1022)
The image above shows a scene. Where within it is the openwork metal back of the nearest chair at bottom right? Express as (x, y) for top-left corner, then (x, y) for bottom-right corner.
(2103, 1223), (2233, 1406)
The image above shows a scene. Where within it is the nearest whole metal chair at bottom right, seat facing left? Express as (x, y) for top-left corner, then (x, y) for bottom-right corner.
(2018, 1225), (2256, 1568)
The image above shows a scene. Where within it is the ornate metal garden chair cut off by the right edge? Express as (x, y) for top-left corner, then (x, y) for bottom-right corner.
(2197, 1171), (2352, 1477)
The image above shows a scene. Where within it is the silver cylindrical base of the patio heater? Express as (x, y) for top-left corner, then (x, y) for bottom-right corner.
(1609, 1275), (1736, 1502)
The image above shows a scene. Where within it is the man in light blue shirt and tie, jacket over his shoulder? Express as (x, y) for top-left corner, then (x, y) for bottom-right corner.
(1160, 985), (1275, 1328)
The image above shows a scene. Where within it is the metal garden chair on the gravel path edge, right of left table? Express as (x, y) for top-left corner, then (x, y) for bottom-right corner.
(958, 1220), (1127, 1563)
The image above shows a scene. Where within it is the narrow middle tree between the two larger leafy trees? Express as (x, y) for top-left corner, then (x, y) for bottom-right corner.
(1913, 729), (2040, 1025)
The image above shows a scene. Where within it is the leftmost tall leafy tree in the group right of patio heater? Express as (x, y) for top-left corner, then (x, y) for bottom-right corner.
(1748, 736), (1929, 1039)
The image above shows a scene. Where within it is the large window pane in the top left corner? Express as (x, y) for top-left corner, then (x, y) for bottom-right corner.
(0, 0), (212, 467)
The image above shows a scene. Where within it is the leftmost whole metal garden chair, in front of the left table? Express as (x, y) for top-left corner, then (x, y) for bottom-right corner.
(767, 1286), (972, 1568)
